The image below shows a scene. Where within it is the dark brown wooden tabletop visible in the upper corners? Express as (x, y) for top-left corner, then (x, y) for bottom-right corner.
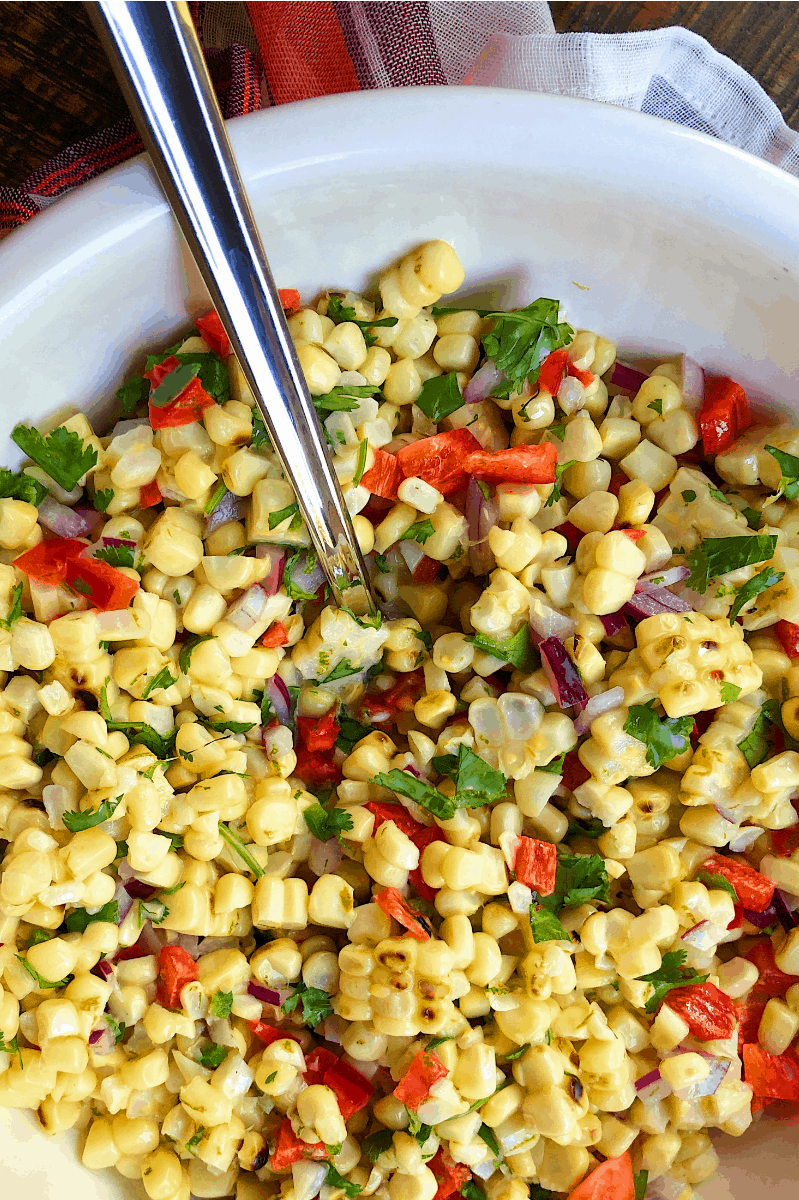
(0, 0), (799, 186)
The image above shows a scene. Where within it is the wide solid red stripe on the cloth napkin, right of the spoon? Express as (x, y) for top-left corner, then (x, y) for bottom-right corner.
(247, 0), (360, 104)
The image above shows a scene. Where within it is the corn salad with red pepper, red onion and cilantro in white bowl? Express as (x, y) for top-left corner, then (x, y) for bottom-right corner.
(0, 241), (799, 1200)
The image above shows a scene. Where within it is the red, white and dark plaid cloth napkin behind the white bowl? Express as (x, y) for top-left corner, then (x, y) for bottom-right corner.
(0, 0), (799, 230)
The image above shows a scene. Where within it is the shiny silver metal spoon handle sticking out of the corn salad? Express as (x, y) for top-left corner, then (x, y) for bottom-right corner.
(85, 0), (377, 614)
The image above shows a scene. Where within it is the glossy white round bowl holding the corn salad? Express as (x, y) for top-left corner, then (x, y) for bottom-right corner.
(0, 88), (799, 1200)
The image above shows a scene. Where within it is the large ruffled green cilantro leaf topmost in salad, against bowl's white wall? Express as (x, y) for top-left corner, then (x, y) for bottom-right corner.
(482, 298), (575, 396)
